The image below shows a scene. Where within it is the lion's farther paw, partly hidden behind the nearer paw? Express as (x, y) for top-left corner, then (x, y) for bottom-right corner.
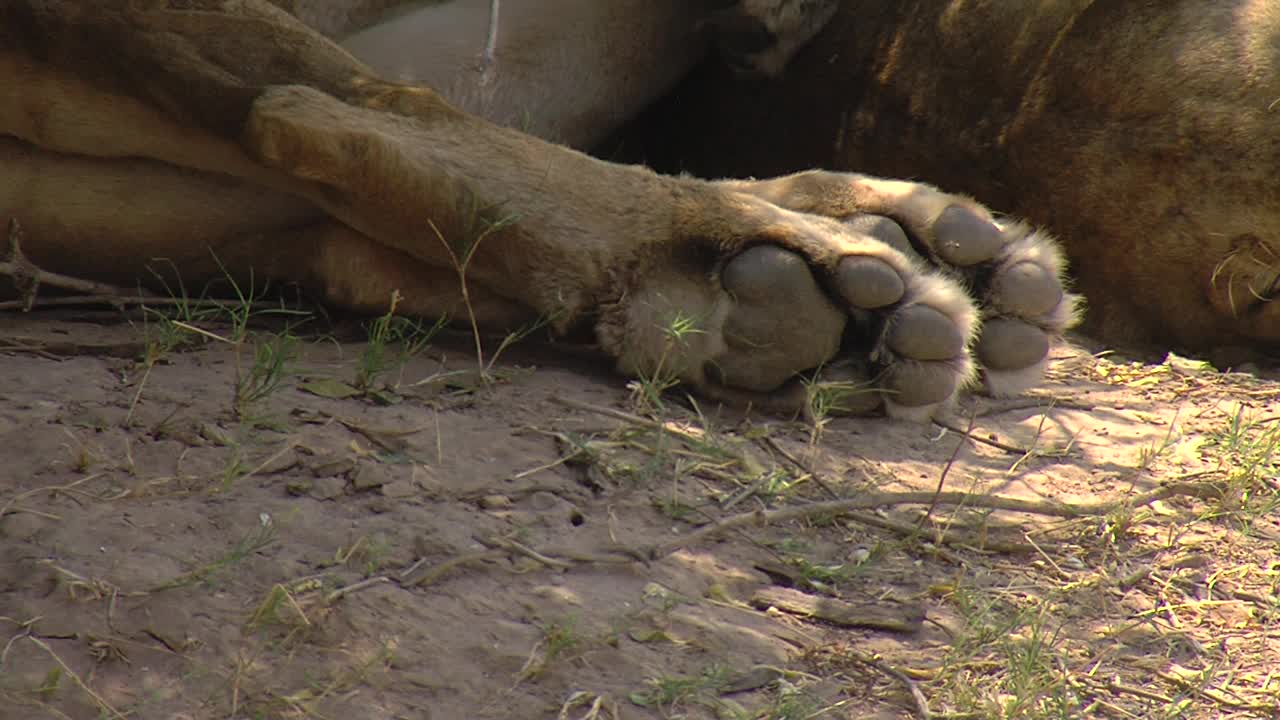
(730, 172), (1082, 396)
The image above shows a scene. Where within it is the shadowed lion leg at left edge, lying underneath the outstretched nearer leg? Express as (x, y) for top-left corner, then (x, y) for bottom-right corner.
(0, 132), (532, 328)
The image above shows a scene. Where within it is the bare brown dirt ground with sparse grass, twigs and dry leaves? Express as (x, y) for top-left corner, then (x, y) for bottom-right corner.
(0, 304), (1280, 720)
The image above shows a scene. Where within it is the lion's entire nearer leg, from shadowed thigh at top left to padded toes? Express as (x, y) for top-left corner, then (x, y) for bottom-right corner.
(0, 0), (993, 418)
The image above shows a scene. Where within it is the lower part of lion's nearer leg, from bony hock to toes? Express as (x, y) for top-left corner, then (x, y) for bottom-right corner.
(238, 82), (977, 418)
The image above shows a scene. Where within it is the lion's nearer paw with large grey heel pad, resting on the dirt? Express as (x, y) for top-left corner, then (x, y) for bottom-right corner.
(598, 184), (978, 419)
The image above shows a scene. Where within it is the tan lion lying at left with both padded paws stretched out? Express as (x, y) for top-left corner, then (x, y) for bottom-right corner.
(0, 0), (1078, 419)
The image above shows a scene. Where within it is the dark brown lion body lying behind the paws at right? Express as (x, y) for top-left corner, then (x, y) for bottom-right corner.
(611, 0), (1280, 366)
